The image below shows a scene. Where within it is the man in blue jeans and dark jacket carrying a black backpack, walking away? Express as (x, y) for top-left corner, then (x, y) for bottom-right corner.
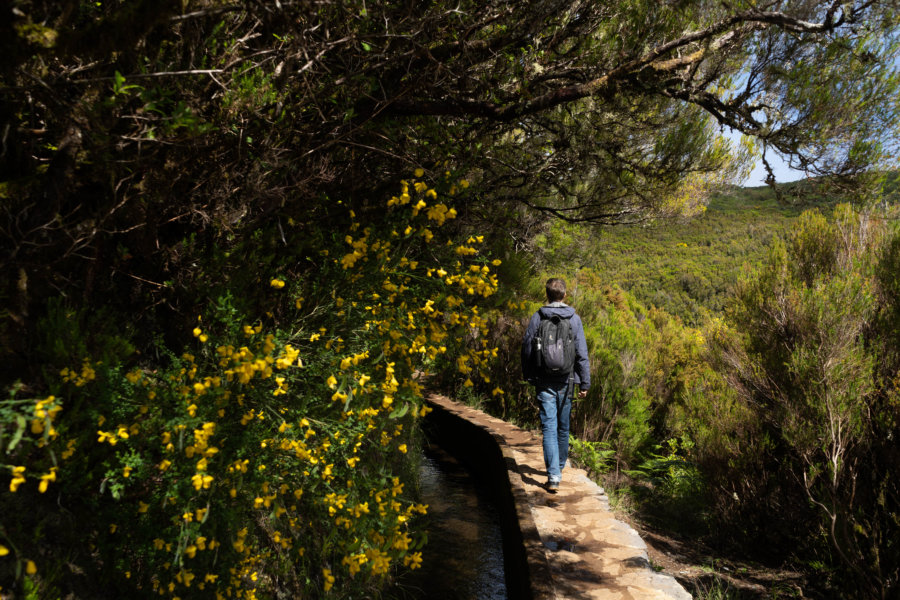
(522, 277), (591, 493)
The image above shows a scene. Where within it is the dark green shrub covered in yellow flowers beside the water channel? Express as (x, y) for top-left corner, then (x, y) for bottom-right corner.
(0, 172), (497, 599)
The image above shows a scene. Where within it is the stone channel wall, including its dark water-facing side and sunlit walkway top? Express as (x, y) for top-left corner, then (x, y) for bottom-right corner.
(425, 395), (691, 600)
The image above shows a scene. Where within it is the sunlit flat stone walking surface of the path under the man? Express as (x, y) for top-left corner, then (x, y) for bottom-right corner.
(428, 395), (691, 600)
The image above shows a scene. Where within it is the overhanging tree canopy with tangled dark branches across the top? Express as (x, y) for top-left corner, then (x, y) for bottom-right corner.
(0, 0), (900, 390)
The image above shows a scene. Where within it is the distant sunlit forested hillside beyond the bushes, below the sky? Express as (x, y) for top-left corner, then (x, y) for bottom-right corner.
(535, 186), (848, 327)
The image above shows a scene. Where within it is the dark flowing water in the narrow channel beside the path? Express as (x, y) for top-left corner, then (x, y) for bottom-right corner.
(392, 446), (507, 600)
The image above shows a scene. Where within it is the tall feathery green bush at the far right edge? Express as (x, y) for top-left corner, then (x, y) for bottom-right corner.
(711, 206), (900, 598)
